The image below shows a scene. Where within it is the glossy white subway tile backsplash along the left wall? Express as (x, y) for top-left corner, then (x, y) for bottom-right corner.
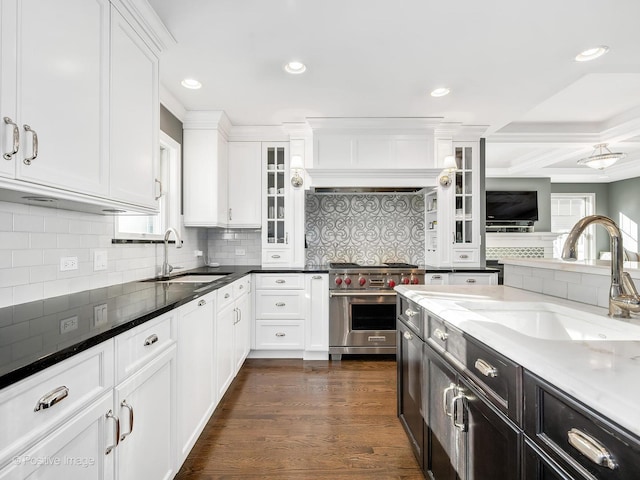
(0, 202), (207, 307)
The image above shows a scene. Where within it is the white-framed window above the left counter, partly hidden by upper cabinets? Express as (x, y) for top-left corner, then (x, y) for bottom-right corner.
(115, 132), (182, 240)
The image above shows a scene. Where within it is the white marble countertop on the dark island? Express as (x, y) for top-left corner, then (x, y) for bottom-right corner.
(396, 285), (640, 436)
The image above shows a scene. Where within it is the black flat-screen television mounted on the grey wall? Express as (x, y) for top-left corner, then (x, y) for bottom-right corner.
(486, 191), (538, 224)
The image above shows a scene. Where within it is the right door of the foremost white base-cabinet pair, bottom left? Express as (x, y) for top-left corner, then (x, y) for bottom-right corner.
(115, 347), (176, 480)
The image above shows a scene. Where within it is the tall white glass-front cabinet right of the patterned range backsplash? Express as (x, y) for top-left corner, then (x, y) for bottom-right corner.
(425, 142), (481, 267)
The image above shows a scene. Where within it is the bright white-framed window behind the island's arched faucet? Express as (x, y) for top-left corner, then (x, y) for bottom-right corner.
(551, 193), (596, 260)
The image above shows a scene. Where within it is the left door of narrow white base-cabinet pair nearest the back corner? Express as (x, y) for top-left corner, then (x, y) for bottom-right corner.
(215, 304), (238, 401)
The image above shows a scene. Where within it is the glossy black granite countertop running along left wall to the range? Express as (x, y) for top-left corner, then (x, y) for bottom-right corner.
(0, 265), (328, 388)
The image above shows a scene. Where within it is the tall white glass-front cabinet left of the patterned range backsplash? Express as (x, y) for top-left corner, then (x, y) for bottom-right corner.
(262, 142), (291, 265)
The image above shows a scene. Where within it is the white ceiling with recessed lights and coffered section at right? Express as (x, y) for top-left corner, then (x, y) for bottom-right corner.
(149, 0), (640, 182)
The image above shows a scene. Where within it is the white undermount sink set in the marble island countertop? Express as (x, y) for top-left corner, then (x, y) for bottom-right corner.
(458, 302), (640, 341)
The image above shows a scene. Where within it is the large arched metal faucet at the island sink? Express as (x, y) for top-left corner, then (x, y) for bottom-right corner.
(562, 215), (640, 318)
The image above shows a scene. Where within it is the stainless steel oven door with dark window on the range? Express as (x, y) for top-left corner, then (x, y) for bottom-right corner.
(329, 291), (396, 353)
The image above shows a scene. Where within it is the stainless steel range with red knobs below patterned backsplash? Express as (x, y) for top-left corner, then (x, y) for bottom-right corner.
(329, 263), (424, 360)
